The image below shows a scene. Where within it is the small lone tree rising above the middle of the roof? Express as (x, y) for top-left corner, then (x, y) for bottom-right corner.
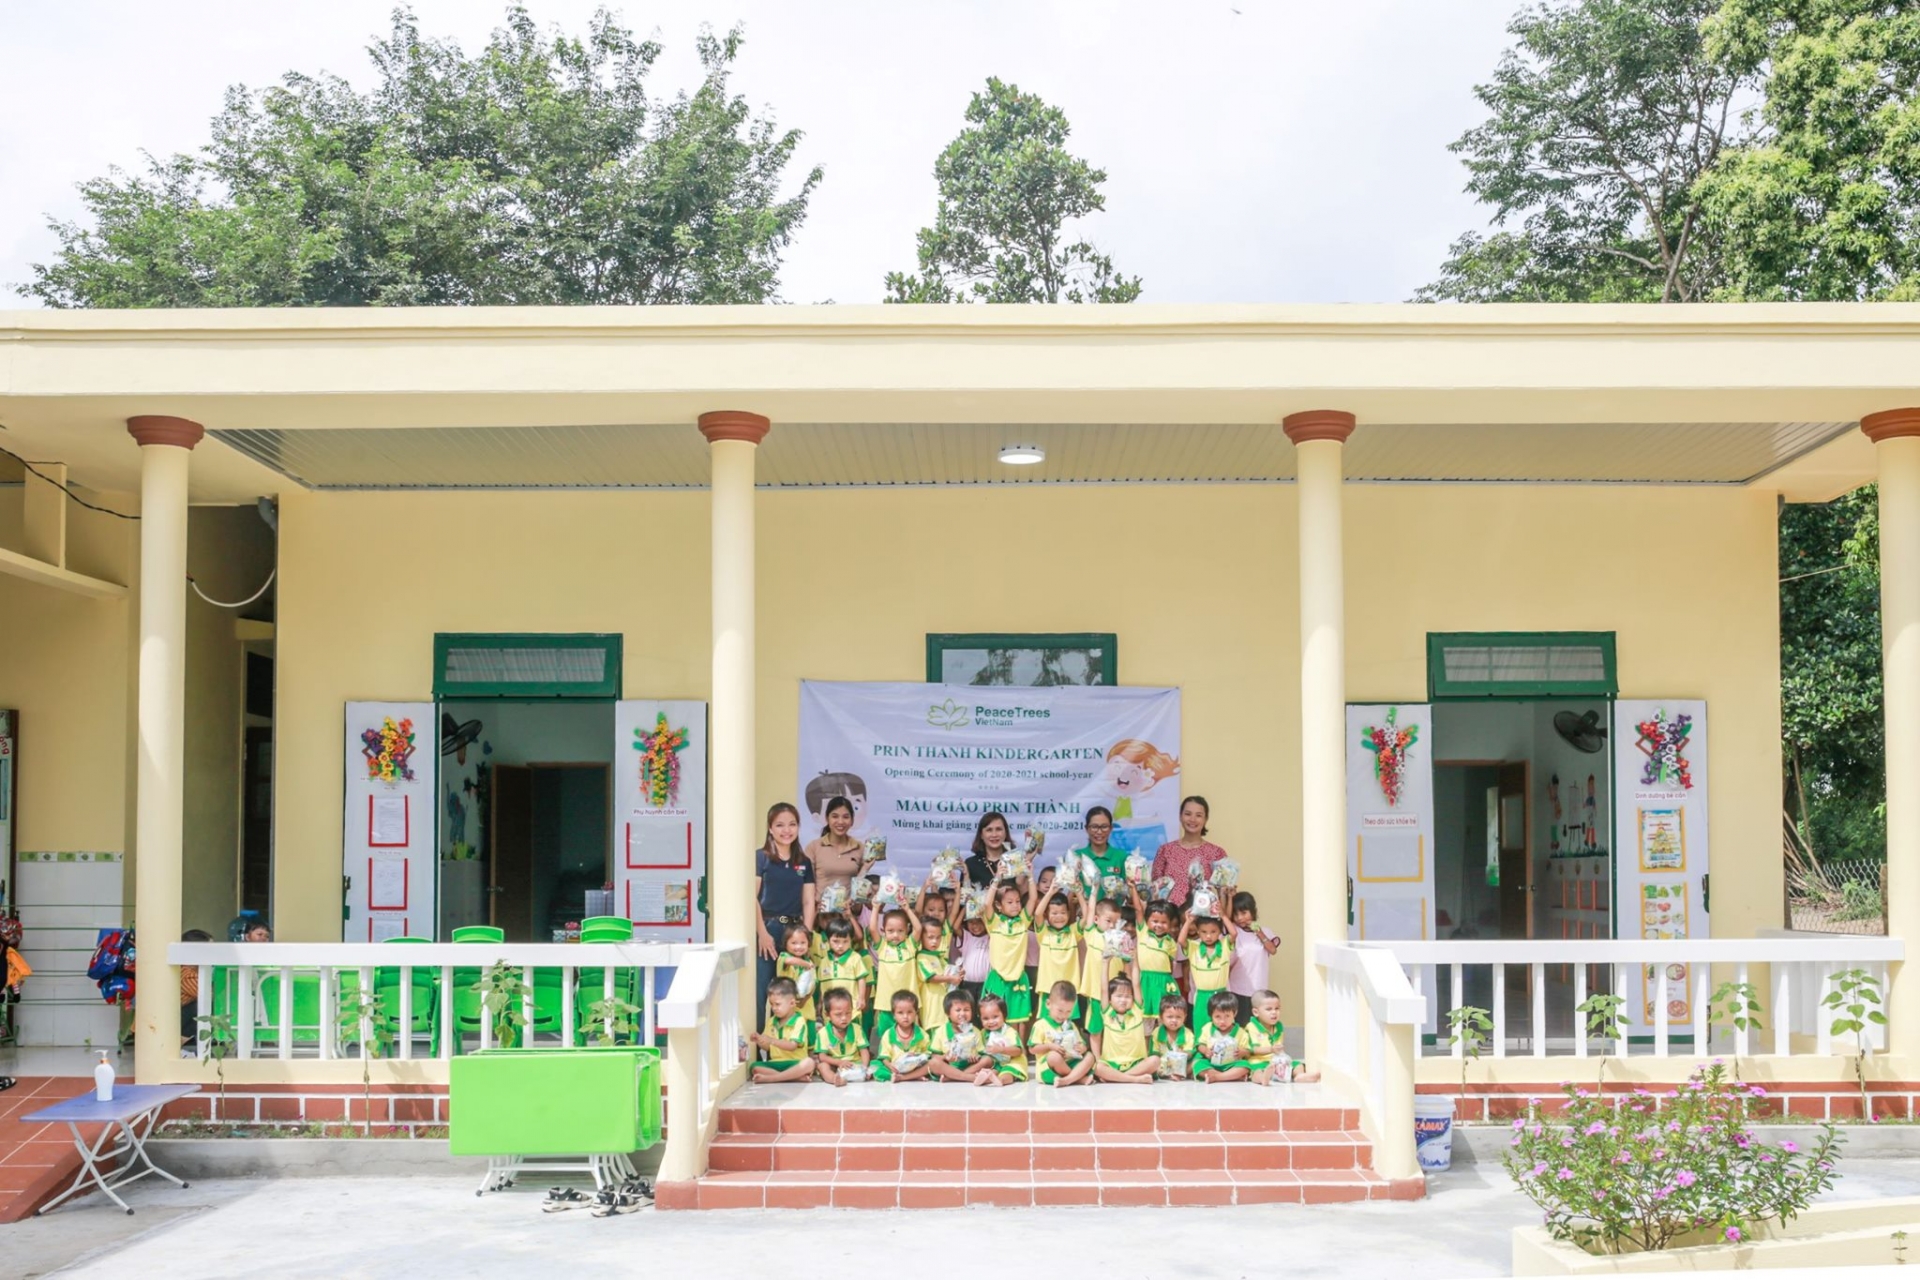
(887, 79), (1140, 303)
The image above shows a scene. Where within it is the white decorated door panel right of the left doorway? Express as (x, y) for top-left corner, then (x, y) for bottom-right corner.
(612, 700), (710, 942)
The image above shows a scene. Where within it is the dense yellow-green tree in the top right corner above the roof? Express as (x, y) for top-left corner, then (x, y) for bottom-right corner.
(1701, 0), (1920, 301)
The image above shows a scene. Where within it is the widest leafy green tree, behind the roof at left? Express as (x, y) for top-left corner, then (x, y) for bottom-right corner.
(21, 6), (820, 307)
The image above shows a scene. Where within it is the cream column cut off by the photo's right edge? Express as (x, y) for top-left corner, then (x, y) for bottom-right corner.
(1860, 409), (1920, 1063)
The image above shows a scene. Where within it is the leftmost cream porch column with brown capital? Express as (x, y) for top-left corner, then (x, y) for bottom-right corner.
(127, 416), (205, 1084)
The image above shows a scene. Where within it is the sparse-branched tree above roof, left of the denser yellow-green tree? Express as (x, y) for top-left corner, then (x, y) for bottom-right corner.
(1415, 0), (1753, 301)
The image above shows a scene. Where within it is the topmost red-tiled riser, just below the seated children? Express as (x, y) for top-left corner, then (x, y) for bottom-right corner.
(720, 1107), (1359, 1138)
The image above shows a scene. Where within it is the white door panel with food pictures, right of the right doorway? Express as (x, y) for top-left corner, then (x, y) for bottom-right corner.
(1613, 699), (1713, 1034)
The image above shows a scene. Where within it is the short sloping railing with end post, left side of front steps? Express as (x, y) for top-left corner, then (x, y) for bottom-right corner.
(659, 946), (753, 1182)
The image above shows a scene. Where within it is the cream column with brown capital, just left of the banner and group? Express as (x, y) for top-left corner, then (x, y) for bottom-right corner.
(701, 411), (768, 951)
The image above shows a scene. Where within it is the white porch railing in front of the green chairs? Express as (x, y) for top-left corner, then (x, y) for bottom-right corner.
(167, 942), (691, 1061)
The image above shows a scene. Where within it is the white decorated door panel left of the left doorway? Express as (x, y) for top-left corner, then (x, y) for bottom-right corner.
(340, 702), (440, 942)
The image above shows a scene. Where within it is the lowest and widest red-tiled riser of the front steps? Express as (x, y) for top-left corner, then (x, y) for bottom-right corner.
(655, 1169), (1427, 1209)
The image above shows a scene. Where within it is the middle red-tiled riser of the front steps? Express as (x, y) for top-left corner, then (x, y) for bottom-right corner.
(707, 1130), (1373, 1174)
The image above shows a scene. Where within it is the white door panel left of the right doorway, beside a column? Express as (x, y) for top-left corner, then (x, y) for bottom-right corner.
(1346, 702), (1434, 948)
